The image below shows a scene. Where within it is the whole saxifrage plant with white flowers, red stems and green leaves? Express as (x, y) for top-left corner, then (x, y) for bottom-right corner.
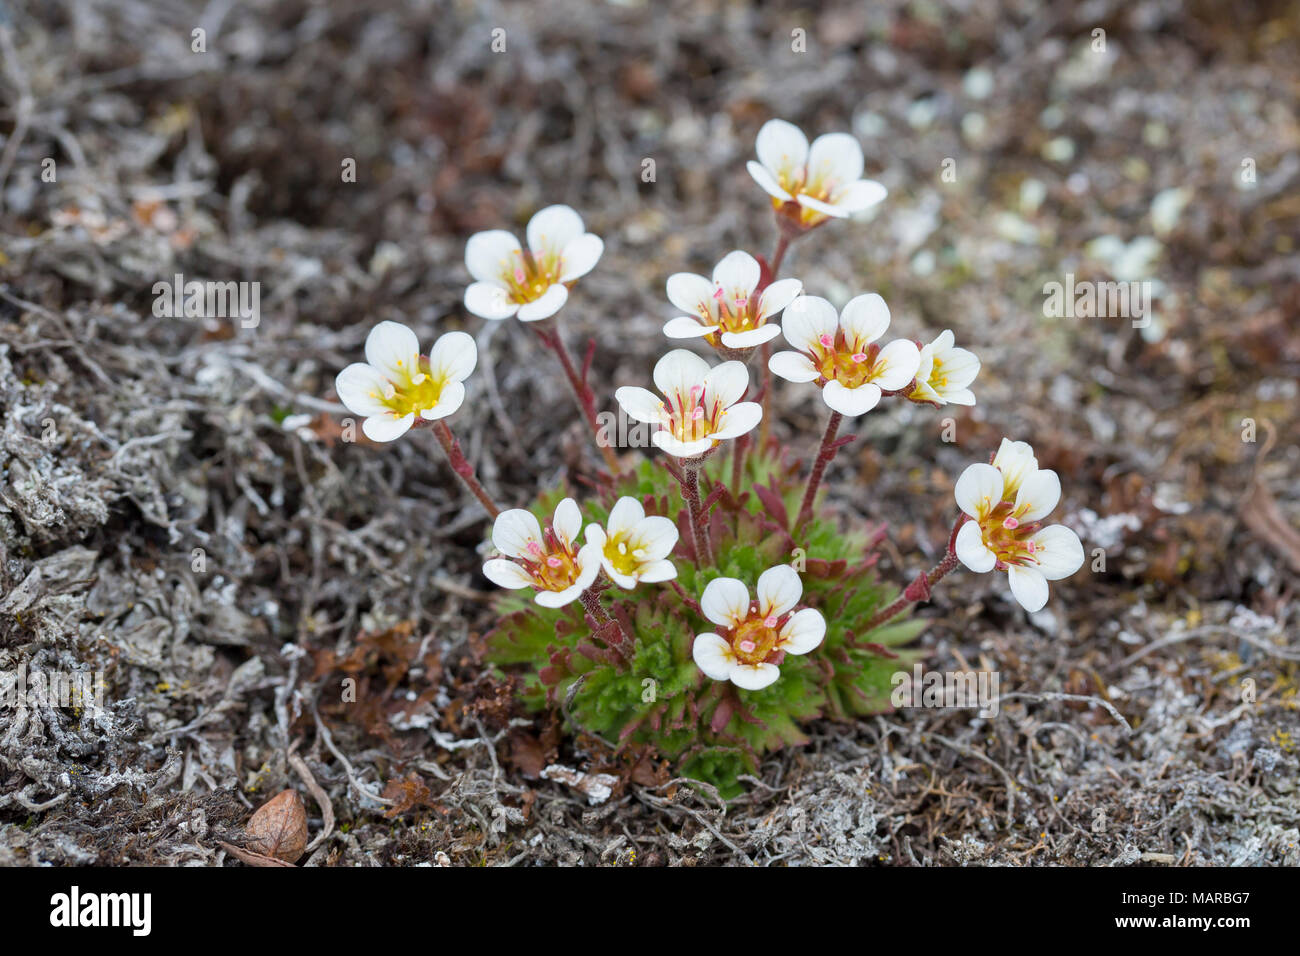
(337, 120), (1083, 797)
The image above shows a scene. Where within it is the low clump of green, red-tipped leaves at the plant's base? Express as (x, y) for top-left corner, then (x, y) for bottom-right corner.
(486, 442), (923, 799)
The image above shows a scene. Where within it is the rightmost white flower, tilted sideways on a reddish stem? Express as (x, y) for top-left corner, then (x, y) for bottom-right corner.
(953, 438), (1083, 611)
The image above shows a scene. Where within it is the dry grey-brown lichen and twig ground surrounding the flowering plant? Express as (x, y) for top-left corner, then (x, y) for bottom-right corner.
(0, 0), (1300, 865)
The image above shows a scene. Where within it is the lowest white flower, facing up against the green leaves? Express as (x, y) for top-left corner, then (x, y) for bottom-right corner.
(692, 564), (826, 691)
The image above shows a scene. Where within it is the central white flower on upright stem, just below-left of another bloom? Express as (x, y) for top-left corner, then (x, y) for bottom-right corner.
(614, 349), (763, 458)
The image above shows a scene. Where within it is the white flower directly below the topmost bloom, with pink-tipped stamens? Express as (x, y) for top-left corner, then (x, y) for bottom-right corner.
(663, 250), (803, 349)
